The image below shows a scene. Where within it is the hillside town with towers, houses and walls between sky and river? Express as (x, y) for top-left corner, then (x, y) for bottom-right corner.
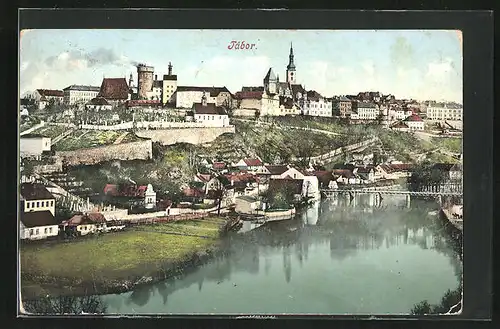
(19, 38), (463, 316)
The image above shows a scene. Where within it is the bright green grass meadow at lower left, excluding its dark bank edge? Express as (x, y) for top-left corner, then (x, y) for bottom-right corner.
(21, 218), (223, 281)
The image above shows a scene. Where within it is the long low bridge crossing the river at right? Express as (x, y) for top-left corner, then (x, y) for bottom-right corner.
(320, 189), (463, 208)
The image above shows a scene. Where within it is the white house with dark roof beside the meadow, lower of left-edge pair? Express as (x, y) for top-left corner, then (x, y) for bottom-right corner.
(19, 210), (59, 240)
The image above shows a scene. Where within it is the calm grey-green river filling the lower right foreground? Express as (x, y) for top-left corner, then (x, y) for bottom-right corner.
(93, 195), (462, 314)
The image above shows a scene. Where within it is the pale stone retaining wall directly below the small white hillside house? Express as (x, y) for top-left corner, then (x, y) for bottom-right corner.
(136, 126), (235, 145)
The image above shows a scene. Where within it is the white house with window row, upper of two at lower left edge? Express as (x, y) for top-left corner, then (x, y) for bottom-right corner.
(21, 183), (56, 216)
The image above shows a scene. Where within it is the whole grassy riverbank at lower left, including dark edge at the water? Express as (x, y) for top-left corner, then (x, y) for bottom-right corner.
(21, 218), (229, 300)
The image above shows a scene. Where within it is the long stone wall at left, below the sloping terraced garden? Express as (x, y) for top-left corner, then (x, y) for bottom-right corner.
(56, 140), (153, 165)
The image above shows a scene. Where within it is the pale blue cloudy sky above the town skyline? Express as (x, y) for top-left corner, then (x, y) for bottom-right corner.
(19, 29), (463, 103)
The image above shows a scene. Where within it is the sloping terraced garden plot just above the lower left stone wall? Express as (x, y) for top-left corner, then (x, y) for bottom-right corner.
(54, 130), (140, 151)
